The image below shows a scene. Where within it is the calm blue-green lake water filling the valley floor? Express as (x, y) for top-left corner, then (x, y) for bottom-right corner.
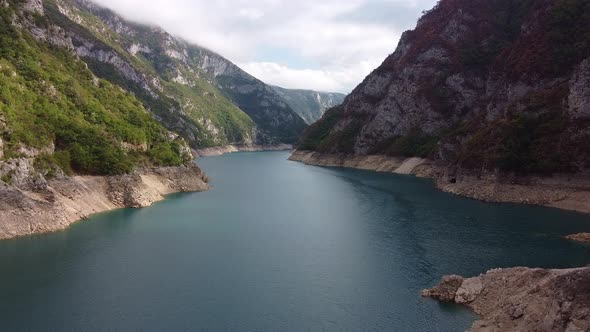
(0, 152), (590, 331)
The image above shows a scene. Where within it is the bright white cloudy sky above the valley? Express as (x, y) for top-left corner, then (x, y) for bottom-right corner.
(95, 0), (436, 93)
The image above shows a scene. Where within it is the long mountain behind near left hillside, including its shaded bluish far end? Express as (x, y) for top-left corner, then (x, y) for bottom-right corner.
(43, 0), (306, 148)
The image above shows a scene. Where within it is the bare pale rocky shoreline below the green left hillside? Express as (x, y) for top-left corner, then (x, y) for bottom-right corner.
(0, 164), (209, 240)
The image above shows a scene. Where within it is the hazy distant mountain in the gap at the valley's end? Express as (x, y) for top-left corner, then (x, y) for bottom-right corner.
(272, 86), (346, 124)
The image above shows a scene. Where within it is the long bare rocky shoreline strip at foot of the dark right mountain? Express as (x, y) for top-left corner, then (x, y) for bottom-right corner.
(289, 151), (590, 213)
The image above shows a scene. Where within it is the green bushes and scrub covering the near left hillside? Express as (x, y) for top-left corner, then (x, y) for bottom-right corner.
(0, 2), (185, 174)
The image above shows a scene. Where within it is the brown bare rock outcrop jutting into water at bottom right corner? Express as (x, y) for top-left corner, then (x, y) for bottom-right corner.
(422, 267), (590, 332)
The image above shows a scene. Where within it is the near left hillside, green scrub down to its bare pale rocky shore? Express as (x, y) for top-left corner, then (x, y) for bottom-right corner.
(0, 0), (209, 239)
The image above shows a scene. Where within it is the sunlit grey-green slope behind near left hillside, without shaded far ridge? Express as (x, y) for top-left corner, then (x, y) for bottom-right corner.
(44, 0), (255, 147)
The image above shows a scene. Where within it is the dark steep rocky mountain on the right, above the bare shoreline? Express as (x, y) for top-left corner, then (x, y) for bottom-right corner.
(299, 0), (590, 174)
